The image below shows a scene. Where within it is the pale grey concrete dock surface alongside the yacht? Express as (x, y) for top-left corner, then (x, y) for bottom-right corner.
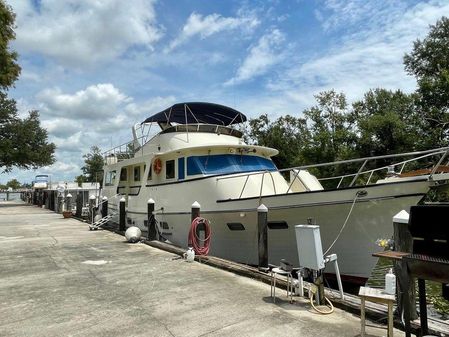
(0, 201), (403, 337)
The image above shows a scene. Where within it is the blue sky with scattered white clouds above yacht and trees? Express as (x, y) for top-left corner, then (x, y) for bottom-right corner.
(0, 0), (449, 183)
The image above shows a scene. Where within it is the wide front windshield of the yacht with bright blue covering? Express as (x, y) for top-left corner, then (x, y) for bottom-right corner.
(187, 154), (276, 175)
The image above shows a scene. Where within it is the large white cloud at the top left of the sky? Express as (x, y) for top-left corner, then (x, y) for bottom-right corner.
(11, 0), (162, 65)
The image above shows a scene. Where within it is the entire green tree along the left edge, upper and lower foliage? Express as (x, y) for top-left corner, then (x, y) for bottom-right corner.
(0, 0), (55, 172)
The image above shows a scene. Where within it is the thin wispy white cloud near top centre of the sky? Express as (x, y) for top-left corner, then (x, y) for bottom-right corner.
(165, 13), (260, 52)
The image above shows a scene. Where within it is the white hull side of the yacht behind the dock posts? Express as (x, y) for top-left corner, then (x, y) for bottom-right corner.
(103, 178), (429, 279)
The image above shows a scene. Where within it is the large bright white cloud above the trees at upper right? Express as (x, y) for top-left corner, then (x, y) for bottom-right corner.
(268, 1), (449, 108)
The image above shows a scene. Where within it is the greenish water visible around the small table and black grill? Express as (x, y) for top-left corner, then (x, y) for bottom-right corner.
(366, 258), (449, 320)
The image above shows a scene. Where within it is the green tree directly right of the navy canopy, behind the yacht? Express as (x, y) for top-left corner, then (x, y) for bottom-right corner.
(246, 114), (308, 169)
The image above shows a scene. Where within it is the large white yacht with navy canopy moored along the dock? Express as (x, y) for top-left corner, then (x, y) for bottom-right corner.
(103, 103), (449, 281)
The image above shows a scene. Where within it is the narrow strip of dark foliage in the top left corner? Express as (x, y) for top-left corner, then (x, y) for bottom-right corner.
(0, 0), (20, 90)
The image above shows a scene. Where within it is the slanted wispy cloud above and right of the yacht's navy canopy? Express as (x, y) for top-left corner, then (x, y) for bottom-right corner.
(225, 29), (285, 85)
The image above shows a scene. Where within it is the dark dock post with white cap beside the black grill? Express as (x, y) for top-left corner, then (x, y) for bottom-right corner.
(393, 210), (418, 320)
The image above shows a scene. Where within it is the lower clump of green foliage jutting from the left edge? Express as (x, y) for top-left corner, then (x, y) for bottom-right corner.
(0, 92), (55, 172)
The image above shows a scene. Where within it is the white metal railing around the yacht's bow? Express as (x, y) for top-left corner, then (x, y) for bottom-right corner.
(217, 147), (449, 199)
